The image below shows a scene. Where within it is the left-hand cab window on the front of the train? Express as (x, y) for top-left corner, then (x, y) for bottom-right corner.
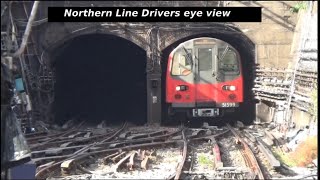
(171, 48), (192, 76)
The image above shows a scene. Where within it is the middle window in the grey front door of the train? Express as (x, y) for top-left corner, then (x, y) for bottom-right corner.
(198, 48), (212, 71)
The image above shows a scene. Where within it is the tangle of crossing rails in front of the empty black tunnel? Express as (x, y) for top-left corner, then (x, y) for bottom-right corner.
(27, 123), (228, 179)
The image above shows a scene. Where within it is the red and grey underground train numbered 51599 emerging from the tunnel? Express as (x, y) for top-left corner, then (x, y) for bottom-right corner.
(166, 37), (243, 119)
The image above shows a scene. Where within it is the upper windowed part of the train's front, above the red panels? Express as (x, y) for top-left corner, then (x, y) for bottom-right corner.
(170, 38), (240, 83)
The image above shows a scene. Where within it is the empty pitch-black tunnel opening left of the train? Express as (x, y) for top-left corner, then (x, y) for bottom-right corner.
(53, 34), (147, 125)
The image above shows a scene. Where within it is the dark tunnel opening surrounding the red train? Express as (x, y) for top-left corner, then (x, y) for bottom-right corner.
(161, 32), (256, 124)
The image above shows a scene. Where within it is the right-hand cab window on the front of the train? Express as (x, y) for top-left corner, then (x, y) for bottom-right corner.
(219, 48), (239, 72)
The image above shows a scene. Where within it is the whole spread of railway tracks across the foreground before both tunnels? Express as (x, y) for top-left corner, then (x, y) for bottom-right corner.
(27, 123), (296, 179)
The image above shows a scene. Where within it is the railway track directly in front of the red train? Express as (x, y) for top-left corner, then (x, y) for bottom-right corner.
(167, 125), (265, 179)
